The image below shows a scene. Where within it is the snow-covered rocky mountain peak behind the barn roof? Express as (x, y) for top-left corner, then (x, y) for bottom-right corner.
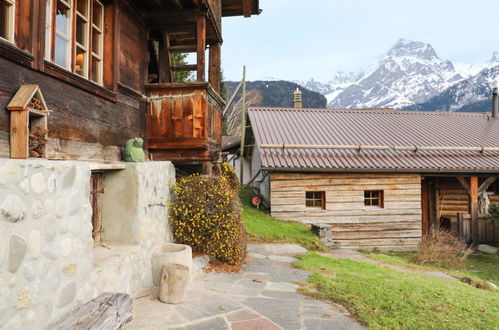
(302, 39), (499, 111)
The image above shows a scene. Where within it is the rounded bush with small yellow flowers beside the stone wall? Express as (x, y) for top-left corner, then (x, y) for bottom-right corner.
(171, 174), (246, 263)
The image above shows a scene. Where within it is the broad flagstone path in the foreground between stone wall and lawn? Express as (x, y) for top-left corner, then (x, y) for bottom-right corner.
(124, 244), (363, 330)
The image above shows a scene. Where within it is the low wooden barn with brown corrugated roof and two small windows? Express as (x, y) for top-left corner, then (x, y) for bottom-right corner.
(247, 93), (499, 250)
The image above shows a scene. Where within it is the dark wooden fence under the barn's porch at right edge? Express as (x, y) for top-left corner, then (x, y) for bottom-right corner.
(453, 213), (499, 244)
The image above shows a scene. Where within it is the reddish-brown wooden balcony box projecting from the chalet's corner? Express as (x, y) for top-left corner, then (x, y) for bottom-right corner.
(146, 82), (225, 164)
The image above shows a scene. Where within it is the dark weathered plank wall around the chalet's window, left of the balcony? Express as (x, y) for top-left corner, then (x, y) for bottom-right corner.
(0, 0), (147, 161)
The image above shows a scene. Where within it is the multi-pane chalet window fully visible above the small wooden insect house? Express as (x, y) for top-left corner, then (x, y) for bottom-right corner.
(45, 0), (104, 84)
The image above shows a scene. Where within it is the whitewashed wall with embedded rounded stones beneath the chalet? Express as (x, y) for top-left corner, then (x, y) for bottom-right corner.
(0, 158), (175, 329)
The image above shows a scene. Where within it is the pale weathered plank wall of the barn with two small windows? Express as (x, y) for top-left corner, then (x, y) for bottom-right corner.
(270, 173), (422, 250)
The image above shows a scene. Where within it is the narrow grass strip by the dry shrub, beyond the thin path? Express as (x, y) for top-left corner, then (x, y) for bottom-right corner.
(365, 251), (499, 286)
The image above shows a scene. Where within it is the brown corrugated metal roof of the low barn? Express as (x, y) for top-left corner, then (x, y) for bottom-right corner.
(248, 108), (499, 173)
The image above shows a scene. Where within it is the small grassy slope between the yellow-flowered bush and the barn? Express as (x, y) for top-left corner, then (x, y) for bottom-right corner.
(241, 190), (325, 250)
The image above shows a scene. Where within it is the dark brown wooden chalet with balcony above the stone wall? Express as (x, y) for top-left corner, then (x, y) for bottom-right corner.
(0, 0), (260, 171)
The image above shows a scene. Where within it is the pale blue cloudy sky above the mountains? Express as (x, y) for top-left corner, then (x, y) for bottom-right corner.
(222, 0), (499, 81)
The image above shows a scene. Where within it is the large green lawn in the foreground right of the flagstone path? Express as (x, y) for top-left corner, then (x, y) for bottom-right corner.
(295, 252), (499, 329)
